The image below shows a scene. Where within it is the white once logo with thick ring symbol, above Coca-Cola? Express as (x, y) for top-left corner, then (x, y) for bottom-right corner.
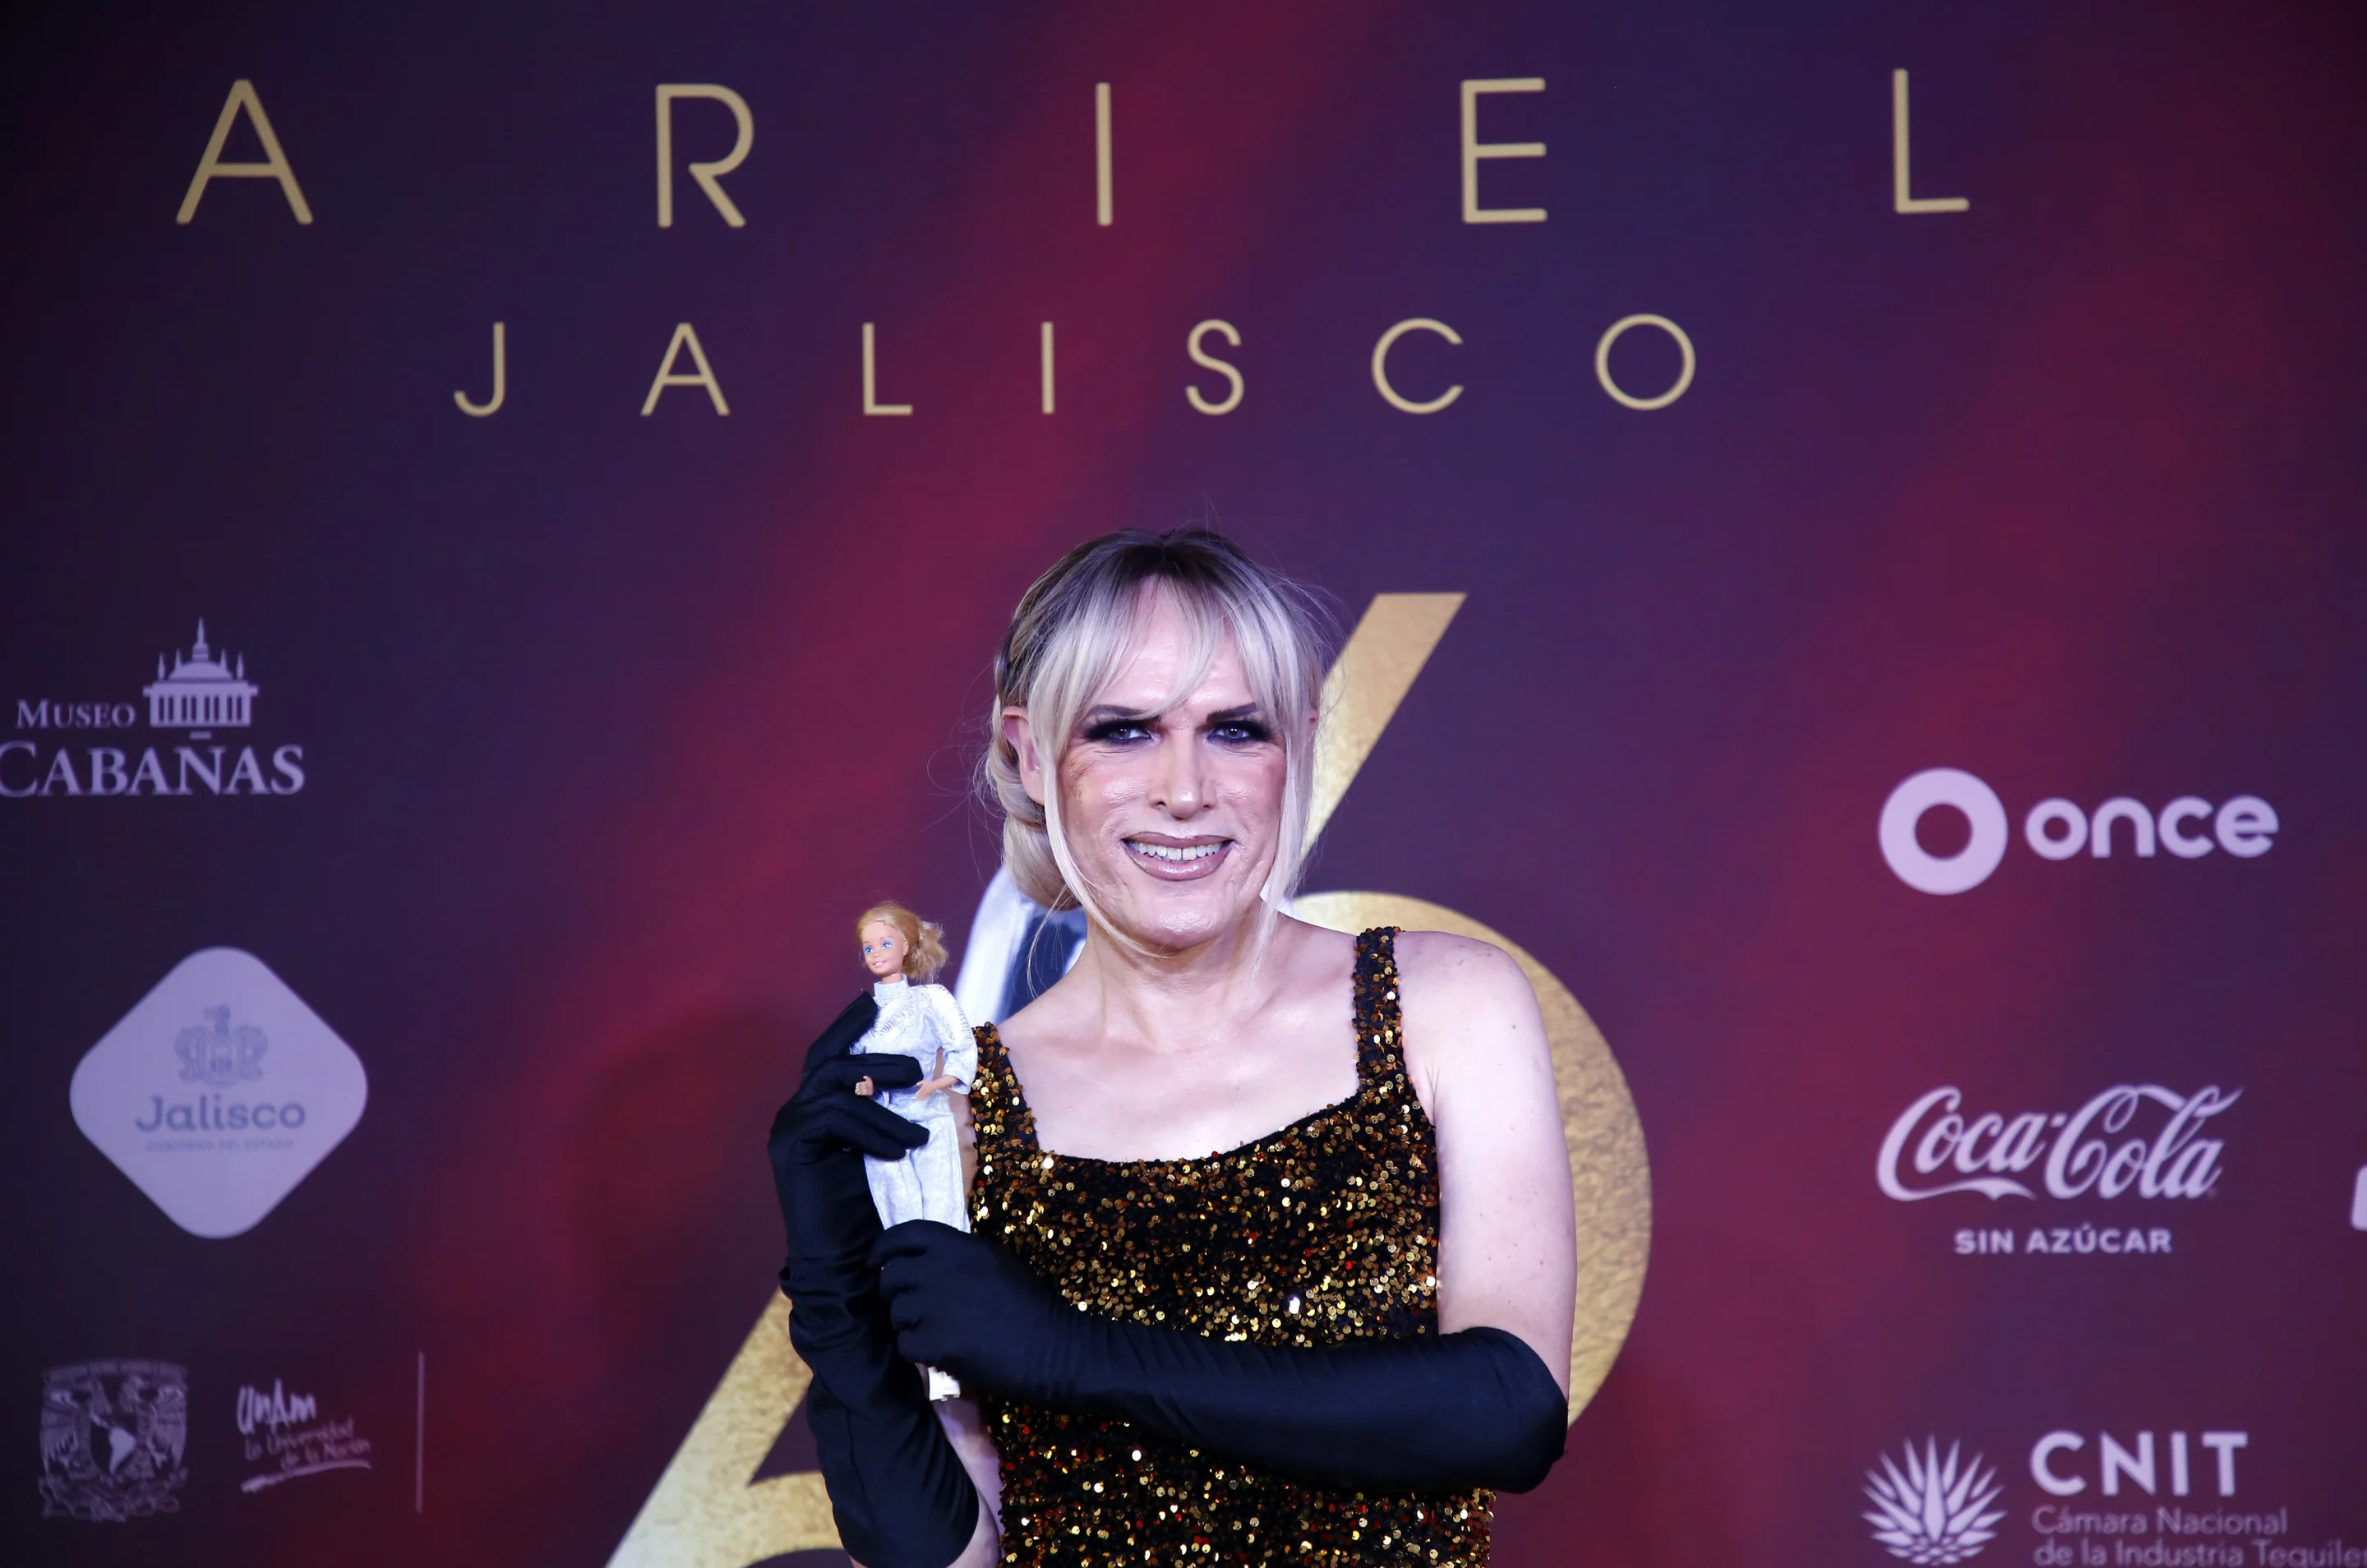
(1875, 768), (2277, 893)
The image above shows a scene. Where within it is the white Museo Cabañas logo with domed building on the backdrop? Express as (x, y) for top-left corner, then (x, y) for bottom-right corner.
(0, 620), (306, 800)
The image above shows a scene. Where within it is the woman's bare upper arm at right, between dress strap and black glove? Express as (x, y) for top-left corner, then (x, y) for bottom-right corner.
(1396, 931), (1576, 1395)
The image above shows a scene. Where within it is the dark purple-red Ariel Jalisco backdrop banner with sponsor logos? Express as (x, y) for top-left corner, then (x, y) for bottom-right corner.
(0, 0), (2367, 1568)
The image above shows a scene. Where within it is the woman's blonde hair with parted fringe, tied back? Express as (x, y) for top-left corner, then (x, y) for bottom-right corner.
(980, 528), (1328, 940)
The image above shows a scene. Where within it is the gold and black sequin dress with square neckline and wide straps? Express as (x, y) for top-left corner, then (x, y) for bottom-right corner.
(971, 929), (1496, 1568)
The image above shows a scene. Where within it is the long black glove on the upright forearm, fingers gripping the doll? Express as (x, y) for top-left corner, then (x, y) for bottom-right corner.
(769, 997), (977, 1568)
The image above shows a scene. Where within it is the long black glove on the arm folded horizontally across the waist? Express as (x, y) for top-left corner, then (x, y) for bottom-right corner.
(871, 1220), (1567, 1492)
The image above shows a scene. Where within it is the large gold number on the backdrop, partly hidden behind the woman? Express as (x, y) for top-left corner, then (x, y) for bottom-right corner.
(608, 594), (1652, 1568)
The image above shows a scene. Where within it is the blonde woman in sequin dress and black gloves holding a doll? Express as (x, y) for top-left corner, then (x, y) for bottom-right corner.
(777, 531), (1574, 1568)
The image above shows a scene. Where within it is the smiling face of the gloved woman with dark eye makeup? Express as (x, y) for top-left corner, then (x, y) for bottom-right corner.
(1016, 594), (1285, 952)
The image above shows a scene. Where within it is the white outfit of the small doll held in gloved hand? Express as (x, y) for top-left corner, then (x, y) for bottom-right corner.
(855, 980), (977, 1400)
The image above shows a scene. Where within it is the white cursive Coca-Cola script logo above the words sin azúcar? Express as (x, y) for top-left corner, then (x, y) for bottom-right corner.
(1875, 1082), (2244, 1203)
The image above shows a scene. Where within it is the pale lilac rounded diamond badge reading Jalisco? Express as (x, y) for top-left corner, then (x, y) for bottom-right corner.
(71, 948), (369, 1236)
